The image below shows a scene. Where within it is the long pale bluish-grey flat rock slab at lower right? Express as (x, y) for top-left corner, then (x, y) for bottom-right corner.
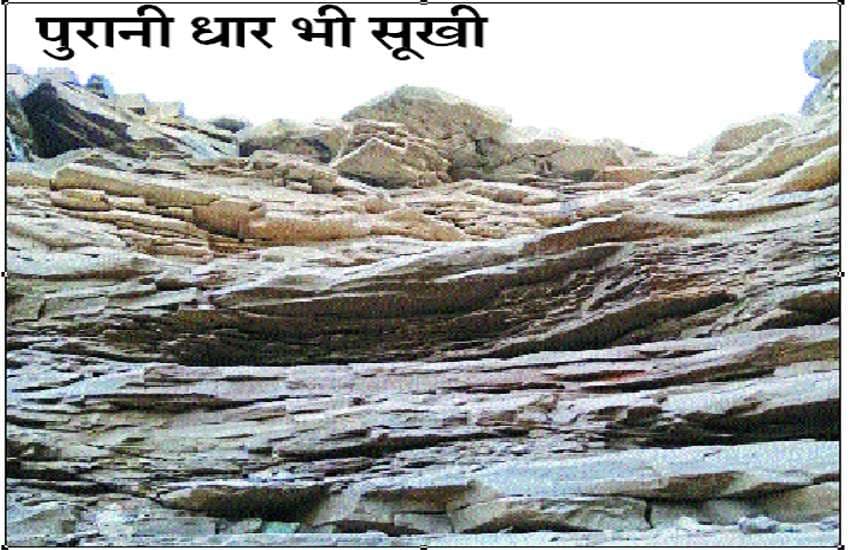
(464, 441), (839, 501)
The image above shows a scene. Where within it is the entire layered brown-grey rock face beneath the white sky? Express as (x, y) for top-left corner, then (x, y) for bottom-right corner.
(6, 42), (840, 546)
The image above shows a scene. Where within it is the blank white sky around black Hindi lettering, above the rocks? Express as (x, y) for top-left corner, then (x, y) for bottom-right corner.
(7, 3), (839, 153)
